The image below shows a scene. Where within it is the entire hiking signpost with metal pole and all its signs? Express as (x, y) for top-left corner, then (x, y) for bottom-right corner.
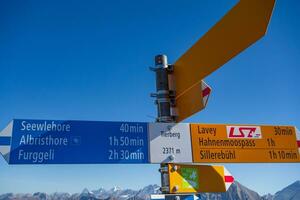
(0, 0), (300, 197)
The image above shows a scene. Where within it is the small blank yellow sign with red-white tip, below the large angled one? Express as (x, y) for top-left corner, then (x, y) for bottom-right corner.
(176, 81), (211, 122)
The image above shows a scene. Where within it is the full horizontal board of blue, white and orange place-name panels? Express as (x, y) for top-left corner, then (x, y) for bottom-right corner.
(0, 119), (300, 164)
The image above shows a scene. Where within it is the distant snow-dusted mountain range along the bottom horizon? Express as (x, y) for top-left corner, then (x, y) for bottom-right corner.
(0, 181), (300, 200)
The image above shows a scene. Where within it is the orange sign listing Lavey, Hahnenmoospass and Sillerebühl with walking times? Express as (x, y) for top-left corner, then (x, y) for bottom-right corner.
(190, 124), (300, 163)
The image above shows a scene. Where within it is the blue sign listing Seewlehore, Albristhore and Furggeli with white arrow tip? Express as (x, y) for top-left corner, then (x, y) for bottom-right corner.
(0, 119), (149, 164)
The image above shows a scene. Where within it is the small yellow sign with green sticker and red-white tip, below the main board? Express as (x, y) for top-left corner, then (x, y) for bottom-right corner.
(168, 164), (234, 193)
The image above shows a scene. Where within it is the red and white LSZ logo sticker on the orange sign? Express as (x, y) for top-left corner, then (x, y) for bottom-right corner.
(226, 126), (262, 139)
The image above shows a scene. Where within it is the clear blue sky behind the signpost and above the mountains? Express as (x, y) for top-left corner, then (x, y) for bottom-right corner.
(0, 0), (300, 197)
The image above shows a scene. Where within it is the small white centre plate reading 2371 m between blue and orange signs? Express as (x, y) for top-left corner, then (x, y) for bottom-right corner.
(149, 123), (192, 163)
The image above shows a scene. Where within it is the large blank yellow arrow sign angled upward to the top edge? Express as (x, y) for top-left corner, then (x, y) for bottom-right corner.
(174, 0), (275, 98)
